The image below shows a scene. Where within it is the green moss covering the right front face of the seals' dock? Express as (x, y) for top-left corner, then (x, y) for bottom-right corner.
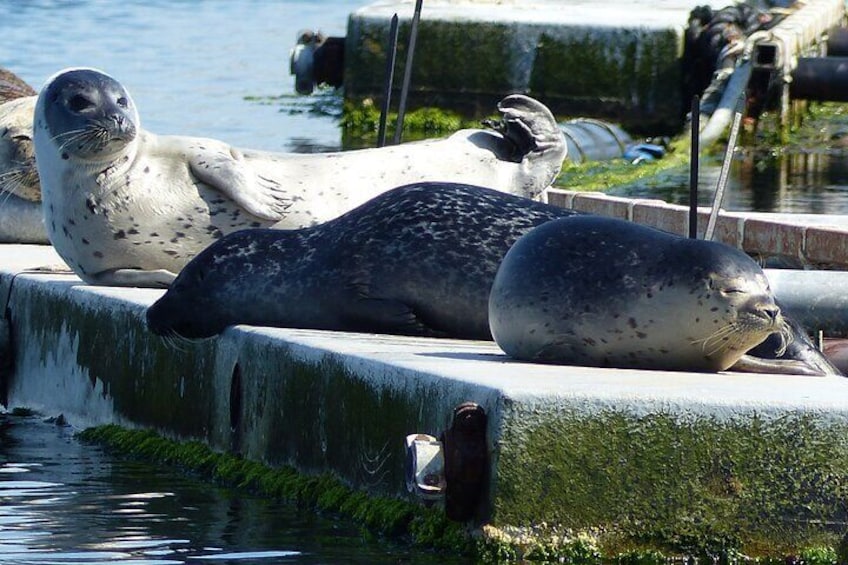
(494, 411), (848, 557)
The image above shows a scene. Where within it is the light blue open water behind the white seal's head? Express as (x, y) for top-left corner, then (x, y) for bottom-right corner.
(0, 0), (358, 151)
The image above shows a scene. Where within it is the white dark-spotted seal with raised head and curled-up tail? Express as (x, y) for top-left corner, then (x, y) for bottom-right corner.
(34, 69), (566, 286)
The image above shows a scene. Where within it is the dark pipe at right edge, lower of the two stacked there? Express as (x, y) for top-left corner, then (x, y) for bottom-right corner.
(789, 57), (848, 102)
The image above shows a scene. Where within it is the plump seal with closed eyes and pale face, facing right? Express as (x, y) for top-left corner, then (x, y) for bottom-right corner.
(489, 216), (791, 372)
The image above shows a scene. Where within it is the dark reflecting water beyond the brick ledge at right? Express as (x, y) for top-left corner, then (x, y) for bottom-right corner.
(610, 151), (848, 214)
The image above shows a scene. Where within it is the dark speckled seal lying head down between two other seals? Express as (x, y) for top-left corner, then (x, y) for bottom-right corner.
(147, 183), (575, 340)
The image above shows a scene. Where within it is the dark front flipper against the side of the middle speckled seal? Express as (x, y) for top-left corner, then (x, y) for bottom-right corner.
(342, 298), (445, 337)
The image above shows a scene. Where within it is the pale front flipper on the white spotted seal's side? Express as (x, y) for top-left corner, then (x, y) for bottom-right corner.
(189, 140), (292, 221)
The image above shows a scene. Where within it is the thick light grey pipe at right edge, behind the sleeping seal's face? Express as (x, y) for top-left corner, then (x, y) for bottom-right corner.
(765, 269), (848, 337)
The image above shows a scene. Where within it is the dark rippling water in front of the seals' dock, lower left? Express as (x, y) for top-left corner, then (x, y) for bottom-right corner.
(0, 414), (459, 565)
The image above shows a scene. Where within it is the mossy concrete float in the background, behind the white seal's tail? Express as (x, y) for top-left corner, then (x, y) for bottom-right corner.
(344, 0), (727, 134)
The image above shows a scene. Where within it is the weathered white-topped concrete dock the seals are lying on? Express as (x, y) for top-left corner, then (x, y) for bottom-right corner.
(0, 242), (848, 555)
